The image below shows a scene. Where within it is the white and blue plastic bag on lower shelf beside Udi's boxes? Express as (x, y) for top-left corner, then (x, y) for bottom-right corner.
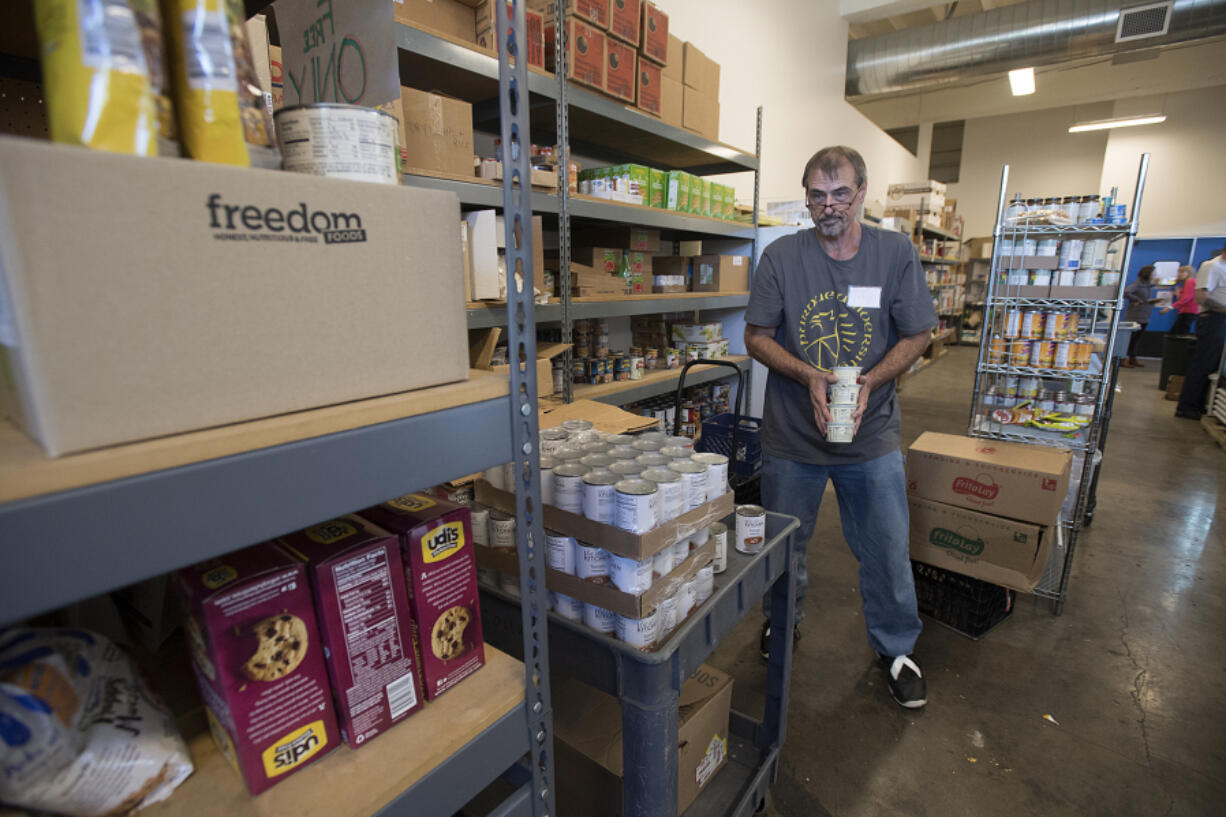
(0, 627), (192, 817)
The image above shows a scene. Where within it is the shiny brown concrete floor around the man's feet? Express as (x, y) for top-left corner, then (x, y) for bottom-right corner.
(711, 347), (1226, 817)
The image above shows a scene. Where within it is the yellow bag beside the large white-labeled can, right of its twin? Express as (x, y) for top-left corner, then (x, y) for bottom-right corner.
(162, 0), (272, 166)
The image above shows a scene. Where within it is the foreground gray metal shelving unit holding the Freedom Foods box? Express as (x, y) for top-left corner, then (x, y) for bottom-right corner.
(0, 0), (554, 817)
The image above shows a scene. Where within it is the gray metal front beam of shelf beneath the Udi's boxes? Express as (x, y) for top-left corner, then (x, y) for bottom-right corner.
(375, 705), (532, 817)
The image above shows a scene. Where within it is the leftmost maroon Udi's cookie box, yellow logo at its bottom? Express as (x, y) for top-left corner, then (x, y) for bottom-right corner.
(174, 543), (340, 795)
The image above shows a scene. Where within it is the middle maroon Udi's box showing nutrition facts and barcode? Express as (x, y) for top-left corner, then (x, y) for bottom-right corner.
(277, 516), (422, 748)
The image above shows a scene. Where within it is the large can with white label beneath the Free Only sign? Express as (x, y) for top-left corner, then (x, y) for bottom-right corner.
(272, 102), (400, 184)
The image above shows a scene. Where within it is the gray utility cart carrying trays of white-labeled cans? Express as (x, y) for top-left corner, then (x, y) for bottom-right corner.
(482, 513), (798, 817)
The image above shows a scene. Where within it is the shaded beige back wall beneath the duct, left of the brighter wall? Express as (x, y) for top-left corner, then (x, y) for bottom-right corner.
(946, 102), (1112, 238)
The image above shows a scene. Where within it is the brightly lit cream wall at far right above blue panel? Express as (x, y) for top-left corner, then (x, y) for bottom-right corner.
(1101, 86), (1226, 237)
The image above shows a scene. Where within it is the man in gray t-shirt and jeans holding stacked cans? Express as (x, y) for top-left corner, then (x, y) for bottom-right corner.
(745, 146), (937, 708)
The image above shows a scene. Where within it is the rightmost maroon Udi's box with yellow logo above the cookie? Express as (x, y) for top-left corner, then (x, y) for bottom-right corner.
(362, 493), (485, 700)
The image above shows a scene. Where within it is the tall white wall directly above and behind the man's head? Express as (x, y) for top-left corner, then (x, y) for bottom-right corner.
(667, 0), (927, 202)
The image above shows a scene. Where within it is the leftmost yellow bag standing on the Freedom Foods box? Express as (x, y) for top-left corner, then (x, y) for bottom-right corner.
(34, 0), (158, 156)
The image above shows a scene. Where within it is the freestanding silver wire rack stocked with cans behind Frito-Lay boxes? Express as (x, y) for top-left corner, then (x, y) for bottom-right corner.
(969, 153), (1150, 615)
